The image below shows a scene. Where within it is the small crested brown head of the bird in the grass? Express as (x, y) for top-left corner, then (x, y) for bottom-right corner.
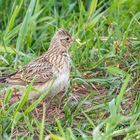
(51, 28), (74, 49)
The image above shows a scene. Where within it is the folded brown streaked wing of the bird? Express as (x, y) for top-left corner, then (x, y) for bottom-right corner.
(6, 60), (53, 85)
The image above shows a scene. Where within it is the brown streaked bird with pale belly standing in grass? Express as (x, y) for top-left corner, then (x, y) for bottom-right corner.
(0, 28), (75, 100)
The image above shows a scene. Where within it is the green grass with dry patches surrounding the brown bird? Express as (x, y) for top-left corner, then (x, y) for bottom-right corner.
(0, 0), (140, 140)
